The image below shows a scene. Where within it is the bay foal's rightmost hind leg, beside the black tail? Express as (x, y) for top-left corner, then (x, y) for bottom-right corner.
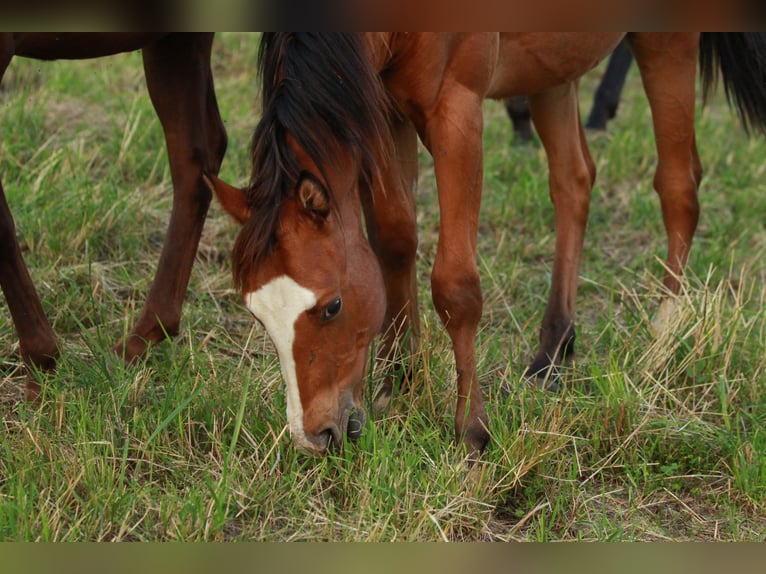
(630, 33), (702, 318)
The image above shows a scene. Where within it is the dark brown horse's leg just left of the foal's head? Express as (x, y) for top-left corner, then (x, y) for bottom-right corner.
(116, 34), (226, 361)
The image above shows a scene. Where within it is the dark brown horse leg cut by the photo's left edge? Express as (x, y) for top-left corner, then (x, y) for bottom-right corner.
(0, 41), (58, 400)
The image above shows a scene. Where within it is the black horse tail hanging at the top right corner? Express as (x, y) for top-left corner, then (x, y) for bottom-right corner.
(699, 32), (766, 135)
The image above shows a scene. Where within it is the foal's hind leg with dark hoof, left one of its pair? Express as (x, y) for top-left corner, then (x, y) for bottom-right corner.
(525, 83), (596, 385)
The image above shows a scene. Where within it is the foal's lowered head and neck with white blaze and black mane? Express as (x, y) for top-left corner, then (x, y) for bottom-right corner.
(207, 34), (387, 453)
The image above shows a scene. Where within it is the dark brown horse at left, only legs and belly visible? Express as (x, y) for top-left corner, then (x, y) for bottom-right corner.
(0, 33), (226, 400)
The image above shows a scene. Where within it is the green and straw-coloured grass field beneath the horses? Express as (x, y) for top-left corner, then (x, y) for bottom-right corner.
(0, 34), (766, 541)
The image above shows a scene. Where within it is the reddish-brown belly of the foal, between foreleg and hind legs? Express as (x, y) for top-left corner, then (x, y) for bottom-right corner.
(487, 32), (625, 98)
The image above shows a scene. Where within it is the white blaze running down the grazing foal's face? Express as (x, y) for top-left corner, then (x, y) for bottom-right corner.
(245, 275), (317, 442)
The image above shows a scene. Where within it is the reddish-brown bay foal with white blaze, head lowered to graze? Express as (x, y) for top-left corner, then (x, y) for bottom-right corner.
(206, 33), (766, 460)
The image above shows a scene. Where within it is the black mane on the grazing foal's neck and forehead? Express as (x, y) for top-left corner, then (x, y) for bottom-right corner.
(232, 32), (390, 287)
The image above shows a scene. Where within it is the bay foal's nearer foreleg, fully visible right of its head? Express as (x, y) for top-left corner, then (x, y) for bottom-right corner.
(425, 87), (489, 460)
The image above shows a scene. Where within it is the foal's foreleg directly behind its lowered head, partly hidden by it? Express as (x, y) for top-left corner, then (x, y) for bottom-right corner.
(362, 118), (420, 411)
